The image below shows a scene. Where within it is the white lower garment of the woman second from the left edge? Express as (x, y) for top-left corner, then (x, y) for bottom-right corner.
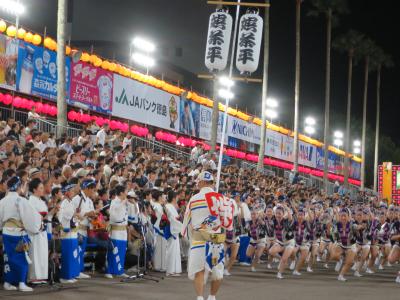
(28, 231), (49, 281)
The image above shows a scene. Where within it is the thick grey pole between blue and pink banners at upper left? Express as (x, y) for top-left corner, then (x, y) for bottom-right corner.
(56, 0), (67, 138)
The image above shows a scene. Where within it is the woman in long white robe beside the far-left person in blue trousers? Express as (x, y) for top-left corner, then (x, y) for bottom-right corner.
(28, 178), (49, 284)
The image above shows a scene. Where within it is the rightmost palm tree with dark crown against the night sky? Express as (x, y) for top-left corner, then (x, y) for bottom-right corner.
(371, 47), (394, 192)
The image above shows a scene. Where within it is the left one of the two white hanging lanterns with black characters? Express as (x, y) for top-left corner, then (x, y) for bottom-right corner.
(205, 9), (232, 71)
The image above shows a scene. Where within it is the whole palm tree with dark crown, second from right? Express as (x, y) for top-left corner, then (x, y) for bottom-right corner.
(359, 39), (376, 190)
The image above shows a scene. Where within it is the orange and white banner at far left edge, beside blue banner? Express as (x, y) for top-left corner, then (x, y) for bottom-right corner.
(0, 34), (18, 90)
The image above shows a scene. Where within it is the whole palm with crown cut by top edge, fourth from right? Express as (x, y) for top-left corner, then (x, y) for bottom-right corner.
(308, 0), (349, 191)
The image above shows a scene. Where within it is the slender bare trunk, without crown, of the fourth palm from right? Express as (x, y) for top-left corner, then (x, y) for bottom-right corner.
(324, 8), (332, 192)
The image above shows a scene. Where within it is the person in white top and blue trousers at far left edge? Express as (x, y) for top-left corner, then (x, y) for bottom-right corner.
(0, 176), (42, 292)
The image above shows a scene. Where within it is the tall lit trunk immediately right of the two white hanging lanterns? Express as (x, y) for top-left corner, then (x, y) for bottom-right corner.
(257, 0), (269, 172)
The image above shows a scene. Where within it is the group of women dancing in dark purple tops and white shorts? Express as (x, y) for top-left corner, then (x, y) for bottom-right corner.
(226, 196), (400, 283)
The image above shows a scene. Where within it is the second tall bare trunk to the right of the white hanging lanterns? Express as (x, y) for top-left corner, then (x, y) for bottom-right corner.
(293, 0), (301, 172)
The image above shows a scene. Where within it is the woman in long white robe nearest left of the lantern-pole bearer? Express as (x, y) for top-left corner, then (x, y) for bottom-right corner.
(165, 191), (182, 276)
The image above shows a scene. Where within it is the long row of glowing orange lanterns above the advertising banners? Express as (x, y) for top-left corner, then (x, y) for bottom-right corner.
(0, 20), (361, 162)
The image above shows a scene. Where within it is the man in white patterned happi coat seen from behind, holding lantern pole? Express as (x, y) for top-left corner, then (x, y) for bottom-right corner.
(182, 172), (233, 300)
